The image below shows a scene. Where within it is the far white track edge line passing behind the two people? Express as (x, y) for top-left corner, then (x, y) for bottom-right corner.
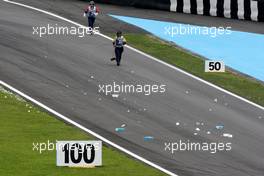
(3, 0), (264, 110)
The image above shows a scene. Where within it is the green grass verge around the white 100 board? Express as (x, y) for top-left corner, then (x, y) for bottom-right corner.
(0, 90), (165, 176)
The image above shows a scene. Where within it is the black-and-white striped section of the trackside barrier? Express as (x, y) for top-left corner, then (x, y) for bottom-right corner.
(170, 0), (264, 21)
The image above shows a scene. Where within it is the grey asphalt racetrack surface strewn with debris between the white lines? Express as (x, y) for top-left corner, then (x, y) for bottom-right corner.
(0, 1), (264, 176)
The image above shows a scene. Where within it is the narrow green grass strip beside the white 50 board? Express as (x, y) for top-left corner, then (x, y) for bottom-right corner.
(125, 34), (264, 106)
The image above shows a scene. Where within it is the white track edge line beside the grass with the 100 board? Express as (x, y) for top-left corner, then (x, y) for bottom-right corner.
(0, 80), (178, 176)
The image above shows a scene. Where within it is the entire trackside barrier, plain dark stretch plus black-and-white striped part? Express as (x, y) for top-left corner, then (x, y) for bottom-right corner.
(96, 0), (264, 22)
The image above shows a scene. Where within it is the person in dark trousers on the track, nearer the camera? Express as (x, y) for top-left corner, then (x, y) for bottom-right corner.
(111, 31), (127, 66)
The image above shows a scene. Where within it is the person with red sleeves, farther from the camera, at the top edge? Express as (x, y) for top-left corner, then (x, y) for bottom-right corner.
(84, 1), (99, 30)
